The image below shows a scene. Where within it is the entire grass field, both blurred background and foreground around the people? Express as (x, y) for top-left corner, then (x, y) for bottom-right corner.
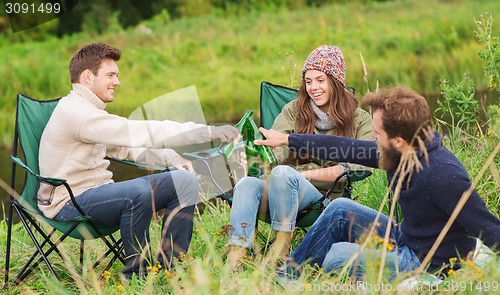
(0, 0), (500, 294)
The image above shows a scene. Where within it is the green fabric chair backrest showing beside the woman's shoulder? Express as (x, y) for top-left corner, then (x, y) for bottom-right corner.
(260, 81), (298, 129)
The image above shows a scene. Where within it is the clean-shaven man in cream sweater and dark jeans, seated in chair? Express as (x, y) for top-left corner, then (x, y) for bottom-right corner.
(38, 43), (239, 278)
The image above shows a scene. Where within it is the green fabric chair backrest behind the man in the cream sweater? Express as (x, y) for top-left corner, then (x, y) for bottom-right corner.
(14, 94), (59, 214)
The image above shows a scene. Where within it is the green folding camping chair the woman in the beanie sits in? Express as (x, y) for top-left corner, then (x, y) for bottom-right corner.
(256, 81), (372, 248)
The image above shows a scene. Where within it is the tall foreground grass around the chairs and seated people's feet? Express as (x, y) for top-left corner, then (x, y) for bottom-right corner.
(0, 128), (500, 294)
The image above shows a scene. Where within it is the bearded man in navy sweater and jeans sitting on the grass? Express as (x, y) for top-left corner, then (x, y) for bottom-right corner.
(255, 87), (500, 279)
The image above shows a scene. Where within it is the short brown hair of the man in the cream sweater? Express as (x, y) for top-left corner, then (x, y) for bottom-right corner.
(69, 43), (121, 83)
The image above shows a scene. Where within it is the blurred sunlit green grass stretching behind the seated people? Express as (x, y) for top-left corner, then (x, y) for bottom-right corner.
(0, 0), (500, 146)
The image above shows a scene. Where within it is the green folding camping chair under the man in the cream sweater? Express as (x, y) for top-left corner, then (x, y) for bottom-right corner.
(5, 94), (125, 286)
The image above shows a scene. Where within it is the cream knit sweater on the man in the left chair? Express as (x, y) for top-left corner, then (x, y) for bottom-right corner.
(38, 84), (211, 218)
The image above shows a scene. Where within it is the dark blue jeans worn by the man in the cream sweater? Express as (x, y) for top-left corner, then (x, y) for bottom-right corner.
(54, 170), (199, 278)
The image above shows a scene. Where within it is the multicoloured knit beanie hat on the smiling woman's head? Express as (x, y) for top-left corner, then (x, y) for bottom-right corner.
(302, 45), (345, 87)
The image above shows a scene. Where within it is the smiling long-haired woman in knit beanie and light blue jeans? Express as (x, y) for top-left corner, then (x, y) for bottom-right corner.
(228, 45), (371, 265)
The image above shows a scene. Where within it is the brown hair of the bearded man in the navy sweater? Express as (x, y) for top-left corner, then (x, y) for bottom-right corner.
(365, 87), (432, 146)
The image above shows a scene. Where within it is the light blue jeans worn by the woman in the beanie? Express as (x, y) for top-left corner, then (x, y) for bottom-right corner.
(228, 165), (323, 248)
